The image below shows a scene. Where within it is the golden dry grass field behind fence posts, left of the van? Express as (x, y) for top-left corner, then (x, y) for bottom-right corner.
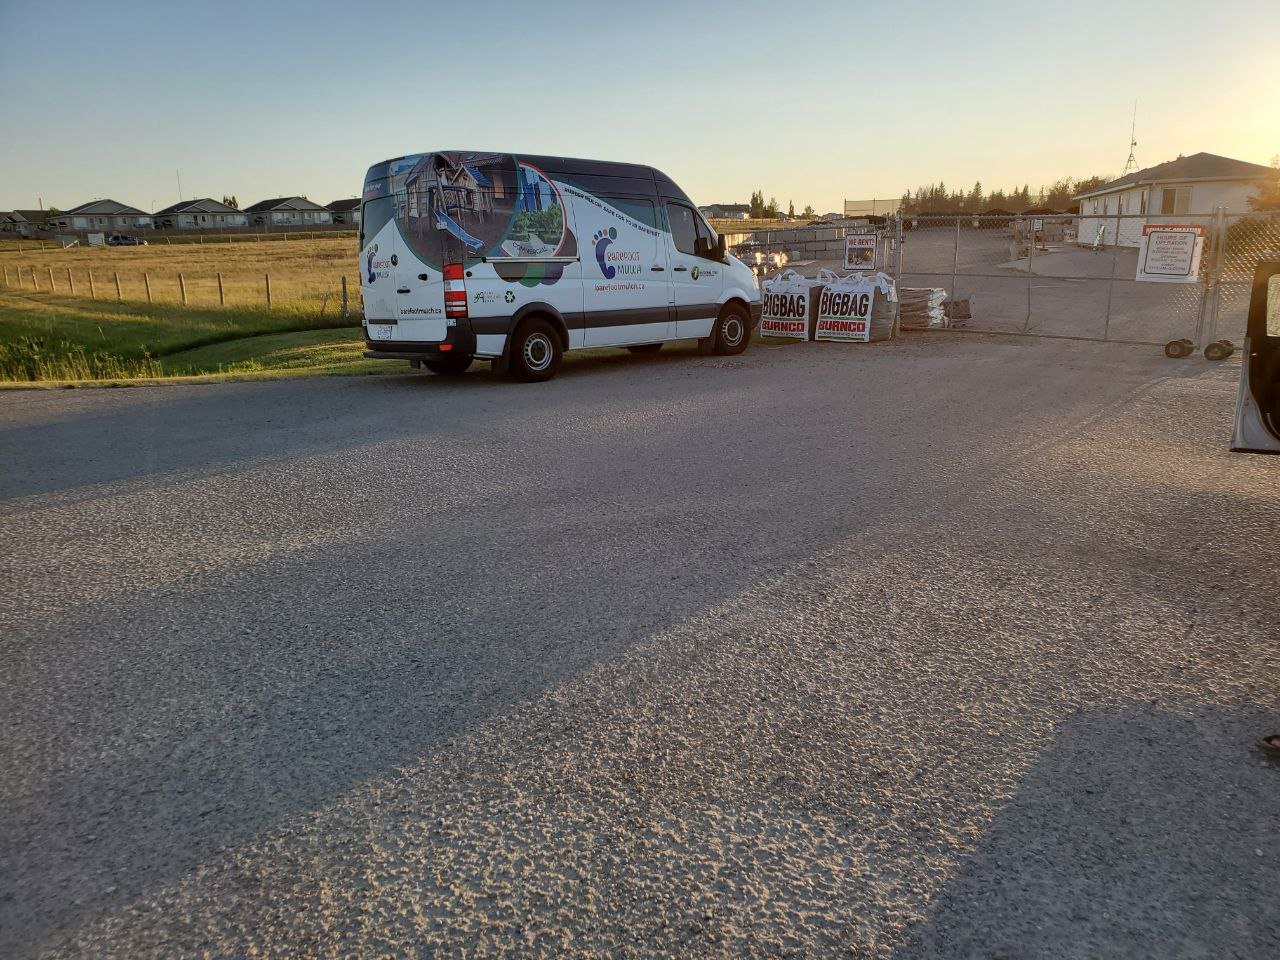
(0, 236), (360, 315)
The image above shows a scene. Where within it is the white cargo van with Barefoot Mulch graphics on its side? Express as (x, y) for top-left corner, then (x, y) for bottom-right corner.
(360, 151), (760, 380)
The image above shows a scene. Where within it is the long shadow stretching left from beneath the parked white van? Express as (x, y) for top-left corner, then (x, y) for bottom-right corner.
(0, 346), (721, 502)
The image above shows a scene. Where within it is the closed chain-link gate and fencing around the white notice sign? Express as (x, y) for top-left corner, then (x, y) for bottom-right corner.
(886, 209), (1280, 347)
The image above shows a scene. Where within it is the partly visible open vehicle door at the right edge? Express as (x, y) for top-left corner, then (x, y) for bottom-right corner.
(1231, 262), (1280, 453)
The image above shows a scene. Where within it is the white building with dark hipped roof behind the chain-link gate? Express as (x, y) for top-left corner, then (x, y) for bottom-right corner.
(1074, 154), (1280, 247)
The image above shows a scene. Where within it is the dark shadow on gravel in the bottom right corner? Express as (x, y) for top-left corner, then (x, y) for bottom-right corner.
(895, 707), (1280, 960)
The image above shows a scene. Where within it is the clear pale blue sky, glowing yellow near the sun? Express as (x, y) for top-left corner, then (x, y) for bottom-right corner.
(0, 0), (1280, 211)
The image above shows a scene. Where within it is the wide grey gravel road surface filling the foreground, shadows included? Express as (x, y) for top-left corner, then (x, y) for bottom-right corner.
(0, 335), (1280, 960)
